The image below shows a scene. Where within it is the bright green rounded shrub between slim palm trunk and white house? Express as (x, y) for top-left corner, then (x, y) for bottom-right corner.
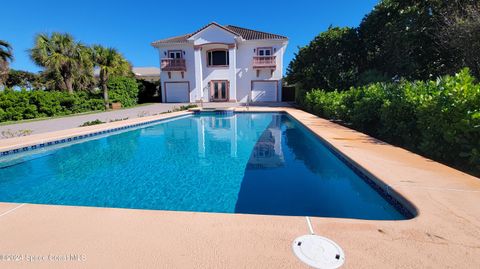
(107, 76), (138, 107)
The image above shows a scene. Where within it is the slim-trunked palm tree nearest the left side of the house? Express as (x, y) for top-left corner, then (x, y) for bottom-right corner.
(92, 45), (131, 109)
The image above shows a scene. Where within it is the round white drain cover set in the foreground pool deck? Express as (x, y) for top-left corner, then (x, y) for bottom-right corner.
(292, 234), (345, 269)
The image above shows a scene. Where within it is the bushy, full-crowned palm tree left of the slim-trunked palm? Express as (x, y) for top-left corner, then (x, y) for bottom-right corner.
(30, 33), (86, 94)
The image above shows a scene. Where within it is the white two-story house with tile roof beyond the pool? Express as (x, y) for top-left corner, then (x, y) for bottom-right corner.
(152, 22), (288, 103)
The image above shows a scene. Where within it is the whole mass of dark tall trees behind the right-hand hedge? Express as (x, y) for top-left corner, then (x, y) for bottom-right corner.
(286, 0), (480, 94)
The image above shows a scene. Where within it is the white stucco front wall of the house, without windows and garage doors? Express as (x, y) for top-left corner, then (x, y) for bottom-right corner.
(158, 26), (287, 103)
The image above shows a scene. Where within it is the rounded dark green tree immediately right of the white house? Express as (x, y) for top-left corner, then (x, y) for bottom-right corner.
(287, 27), (363, 90)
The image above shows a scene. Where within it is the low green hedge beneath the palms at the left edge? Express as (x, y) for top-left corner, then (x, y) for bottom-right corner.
(0, 88), (104, 122)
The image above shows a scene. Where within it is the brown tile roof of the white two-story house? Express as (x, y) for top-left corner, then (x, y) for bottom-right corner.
(152, 22), (288, 46)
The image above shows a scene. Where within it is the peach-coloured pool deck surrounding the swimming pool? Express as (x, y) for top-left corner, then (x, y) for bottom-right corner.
(0, 107), (480, 268)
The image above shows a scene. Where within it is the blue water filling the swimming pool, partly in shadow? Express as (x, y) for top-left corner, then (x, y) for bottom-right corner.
(0, 113), (406, 220)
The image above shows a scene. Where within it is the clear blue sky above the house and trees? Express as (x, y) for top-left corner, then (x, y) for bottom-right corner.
(0, 0), (378, 71)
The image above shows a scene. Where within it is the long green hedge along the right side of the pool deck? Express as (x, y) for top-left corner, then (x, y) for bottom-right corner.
(300, 69), (480, 175)
